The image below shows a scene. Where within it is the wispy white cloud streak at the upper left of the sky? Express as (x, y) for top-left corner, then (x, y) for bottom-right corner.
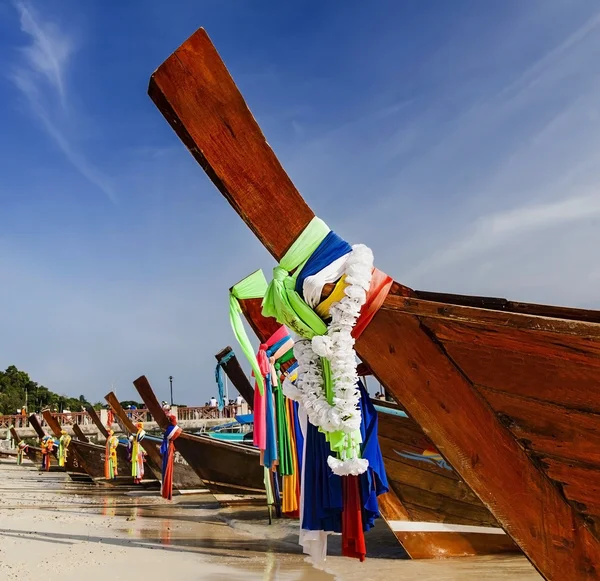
(10, 2), (117, 203)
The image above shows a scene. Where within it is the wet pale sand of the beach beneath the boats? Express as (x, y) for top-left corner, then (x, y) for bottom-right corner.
(0, 459), (540, 581)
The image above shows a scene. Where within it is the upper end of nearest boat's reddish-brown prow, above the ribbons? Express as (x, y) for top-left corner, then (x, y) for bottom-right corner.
(148, 29), (314, 259)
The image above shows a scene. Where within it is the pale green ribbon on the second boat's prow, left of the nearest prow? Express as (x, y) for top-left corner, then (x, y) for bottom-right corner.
(229, 270), (267, 395)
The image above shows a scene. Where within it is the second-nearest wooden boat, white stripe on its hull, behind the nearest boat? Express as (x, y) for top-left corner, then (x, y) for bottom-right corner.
(239, 299), (518, 559)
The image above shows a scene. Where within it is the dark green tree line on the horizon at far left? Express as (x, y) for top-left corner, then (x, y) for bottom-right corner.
(0, 365), (93, 415)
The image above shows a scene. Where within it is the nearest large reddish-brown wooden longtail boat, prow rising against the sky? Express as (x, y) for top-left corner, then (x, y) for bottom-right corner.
(149, 29), (600, 581)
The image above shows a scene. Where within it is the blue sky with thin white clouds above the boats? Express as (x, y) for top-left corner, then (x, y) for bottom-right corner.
(0, 0), (600, 404)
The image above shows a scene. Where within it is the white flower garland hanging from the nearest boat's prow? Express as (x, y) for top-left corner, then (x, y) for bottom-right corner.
(284, 244), (373, 475)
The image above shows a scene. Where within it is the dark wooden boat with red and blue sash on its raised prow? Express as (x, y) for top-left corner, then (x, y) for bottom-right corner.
(133, 375), (265, 498)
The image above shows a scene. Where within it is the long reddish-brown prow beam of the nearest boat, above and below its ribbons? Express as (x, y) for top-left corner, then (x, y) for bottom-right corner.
(149, 29), (600, 581)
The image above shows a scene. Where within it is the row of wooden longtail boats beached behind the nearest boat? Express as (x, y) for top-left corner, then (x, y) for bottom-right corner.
(12, 330), (518, 559)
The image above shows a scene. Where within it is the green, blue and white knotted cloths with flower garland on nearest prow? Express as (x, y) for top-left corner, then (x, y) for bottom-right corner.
(263, 217), (384, 475)
